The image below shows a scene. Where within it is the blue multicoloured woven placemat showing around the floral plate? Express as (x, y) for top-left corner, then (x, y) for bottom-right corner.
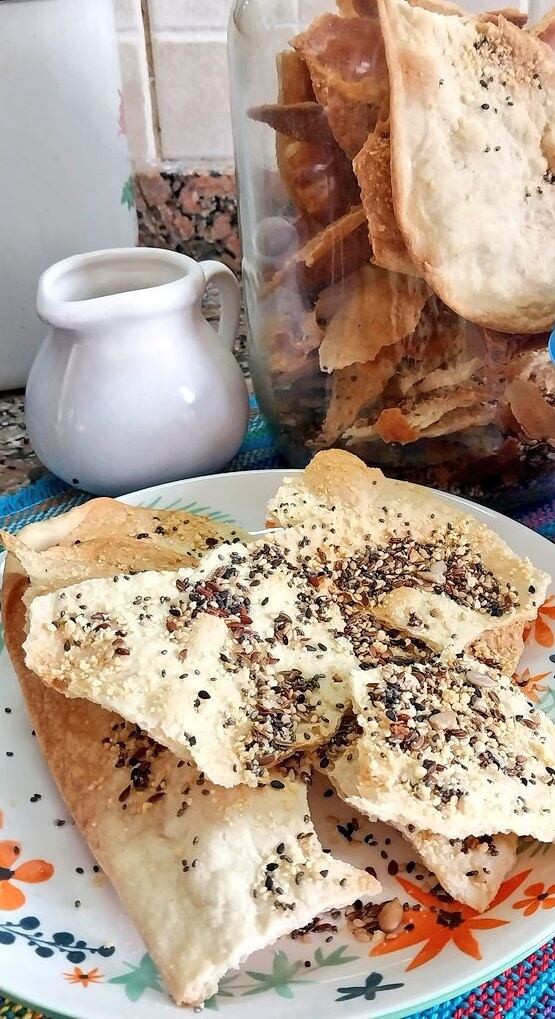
(0, 398), (555, 1019)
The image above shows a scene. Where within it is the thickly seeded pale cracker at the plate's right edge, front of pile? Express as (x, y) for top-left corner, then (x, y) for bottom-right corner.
(320, 657), (555, 842)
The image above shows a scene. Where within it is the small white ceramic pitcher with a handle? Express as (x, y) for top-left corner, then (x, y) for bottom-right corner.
(26, 248), (248, 495)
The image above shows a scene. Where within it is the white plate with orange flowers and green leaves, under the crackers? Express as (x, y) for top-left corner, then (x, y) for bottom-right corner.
(0, 471), (555, 1019)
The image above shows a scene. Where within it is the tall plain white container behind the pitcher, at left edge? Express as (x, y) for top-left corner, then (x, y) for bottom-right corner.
(0, 0), (136, 389)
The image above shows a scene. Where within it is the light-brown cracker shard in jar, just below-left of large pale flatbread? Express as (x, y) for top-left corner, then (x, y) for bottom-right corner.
(316, 265), (431, 372)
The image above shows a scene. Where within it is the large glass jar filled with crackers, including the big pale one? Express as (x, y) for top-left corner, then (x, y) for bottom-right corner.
(230, 0), (555, 498)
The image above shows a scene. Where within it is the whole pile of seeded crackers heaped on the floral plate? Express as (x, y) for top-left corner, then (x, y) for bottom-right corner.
(2, 450), (555, 1006)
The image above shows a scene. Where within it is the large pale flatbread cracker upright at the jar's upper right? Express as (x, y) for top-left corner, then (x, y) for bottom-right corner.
(379, 0), (555, 333)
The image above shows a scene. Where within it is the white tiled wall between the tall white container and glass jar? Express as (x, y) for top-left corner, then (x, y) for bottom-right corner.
(114, 0), (233, 169)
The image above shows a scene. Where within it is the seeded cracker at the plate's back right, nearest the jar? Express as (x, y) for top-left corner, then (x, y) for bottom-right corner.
(268, 449), (549, 652)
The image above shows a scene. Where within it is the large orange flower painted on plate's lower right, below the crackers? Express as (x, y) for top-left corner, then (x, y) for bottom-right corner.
(370, 870), (531, 970)
